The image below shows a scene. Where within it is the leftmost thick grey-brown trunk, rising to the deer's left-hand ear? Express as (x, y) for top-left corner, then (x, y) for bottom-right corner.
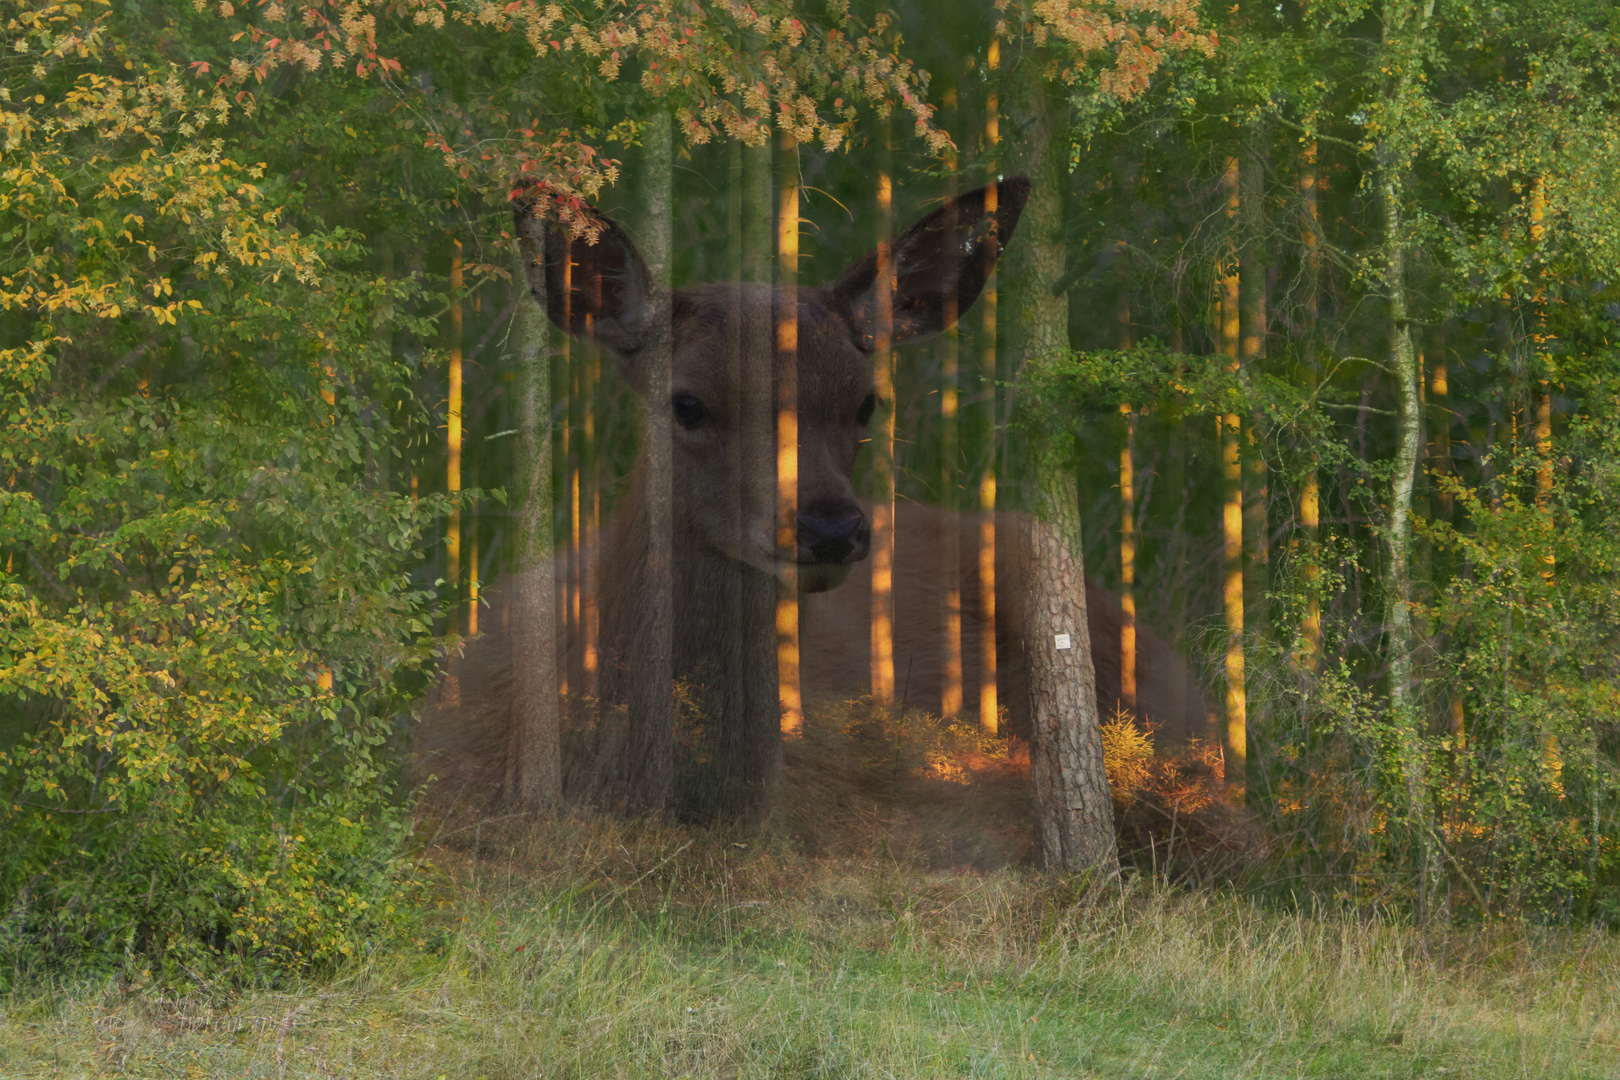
(502, 236), (562, 810)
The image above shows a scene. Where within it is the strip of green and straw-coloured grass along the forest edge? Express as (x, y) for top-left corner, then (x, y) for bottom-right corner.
(0, 818), (1620, 1080)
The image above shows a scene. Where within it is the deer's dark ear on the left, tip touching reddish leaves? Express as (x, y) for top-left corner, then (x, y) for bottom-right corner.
(512, 198), (653, 358)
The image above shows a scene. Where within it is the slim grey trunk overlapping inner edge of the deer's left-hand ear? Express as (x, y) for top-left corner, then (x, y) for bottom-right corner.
(627, 108), (676, 813)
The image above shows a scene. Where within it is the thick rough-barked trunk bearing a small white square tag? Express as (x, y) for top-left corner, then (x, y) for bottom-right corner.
(1004, 57), (1118, 873)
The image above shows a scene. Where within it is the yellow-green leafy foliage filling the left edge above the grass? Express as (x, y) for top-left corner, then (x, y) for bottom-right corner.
(0, 3), (439, 978)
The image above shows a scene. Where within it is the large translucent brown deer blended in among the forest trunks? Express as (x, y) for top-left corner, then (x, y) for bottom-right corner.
(418, 176), (1204, 818)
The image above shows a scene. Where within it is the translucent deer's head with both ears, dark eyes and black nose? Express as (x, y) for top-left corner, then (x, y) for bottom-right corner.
(515, 176), (1029, 593)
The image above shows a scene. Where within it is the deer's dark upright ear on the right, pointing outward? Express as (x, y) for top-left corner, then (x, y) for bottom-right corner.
(833, 176), (1029, 350)
